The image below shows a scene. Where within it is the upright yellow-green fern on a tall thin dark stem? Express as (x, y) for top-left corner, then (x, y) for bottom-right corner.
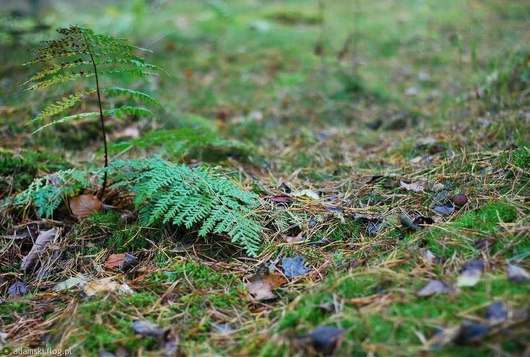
(25, 26), (158, 198)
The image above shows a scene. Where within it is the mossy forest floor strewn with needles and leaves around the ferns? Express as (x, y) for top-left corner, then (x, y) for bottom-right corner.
(0, 0), (530, 356)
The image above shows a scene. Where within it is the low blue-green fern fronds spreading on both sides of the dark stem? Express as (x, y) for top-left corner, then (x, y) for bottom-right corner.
(13, 158), (262, 256)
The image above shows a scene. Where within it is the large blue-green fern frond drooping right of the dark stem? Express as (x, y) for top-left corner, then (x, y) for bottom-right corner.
(111, 158), (262, 256)
